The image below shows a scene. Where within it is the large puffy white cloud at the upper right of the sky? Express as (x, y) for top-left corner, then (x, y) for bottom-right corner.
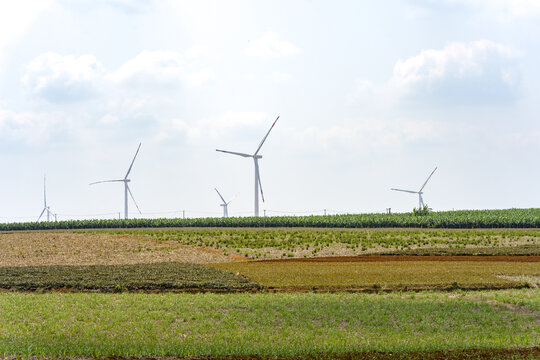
(392, 40), (520, 104)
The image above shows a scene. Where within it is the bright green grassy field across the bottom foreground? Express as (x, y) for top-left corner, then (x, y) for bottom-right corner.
(0, 290), (540, 356)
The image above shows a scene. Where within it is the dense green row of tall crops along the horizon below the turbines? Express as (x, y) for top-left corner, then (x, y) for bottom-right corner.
(0, 208), (540, 231)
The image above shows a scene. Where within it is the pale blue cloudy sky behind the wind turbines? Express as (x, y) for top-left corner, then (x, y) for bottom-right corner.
(0, 0), (540, 222)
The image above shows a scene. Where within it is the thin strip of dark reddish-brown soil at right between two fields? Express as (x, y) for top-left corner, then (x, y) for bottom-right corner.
(255, 255), (540, 263)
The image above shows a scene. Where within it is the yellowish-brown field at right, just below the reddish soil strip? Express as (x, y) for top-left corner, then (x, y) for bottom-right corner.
(213, 257), (540, 291)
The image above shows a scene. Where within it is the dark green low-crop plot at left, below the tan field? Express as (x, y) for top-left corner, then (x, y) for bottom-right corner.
(0, 263), (260, 292)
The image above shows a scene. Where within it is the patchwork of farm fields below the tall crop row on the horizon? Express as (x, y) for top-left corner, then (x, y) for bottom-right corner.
(0, 228), (540, 359)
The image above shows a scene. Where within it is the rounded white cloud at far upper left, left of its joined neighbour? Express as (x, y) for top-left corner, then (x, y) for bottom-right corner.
(22, 52), (103, 102)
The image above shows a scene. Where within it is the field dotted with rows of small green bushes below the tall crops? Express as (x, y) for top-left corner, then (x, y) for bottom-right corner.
(85, 228), (540, 259)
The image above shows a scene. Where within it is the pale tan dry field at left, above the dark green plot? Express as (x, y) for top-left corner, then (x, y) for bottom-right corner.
(0, 231), (235, 267)
